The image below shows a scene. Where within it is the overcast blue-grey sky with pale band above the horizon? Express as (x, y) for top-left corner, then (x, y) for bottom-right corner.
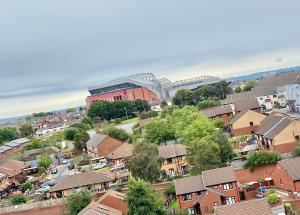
(0, 0), (300, 118)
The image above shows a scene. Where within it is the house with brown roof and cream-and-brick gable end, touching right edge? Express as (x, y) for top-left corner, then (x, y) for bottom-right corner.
(256, 114), (300, 153)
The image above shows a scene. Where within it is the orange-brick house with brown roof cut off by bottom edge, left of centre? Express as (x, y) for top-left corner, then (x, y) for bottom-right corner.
(78, 190), (128, 215)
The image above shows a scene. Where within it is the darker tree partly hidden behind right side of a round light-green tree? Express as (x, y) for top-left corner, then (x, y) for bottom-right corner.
(207, 131), (235, 163)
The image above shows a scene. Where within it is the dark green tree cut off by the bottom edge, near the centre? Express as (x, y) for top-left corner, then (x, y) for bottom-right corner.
(125, 180), (167, 215)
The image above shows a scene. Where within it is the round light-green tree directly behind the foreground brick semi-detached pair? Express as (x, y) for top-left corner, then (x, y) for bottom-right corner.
(187, 138), (221, 175)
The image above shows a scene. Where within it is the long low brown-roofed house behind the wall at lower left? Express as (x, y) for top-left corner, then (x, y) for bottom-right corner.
(50, 172), (115, 198)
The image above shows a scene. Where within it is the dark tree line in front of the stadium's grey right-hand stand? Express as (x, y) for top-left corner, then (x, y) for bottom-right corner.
(173, 81), (233, 107)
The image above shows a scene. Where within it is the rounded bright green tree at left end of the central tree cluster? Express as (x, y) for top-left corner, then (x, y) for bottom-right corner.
(145, 118), (175, 144)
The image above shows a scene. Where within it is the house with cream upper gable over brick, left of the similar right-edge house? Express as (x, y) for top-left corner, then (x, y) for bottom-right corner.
(227, 110), (266, 137)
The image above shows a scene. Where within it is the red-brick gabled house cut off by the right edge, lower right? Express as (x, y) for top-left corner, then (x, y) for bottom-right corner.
(271, 157), (300, 197)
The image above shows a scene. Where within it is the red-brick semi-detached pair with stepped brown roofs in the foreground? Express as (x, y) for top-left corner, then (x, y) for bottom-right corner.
(174, 167), (240, 214)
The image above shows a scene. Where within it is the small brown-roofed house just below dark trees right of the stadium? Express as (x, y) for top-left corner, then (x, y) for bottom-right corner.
(201, 104), (234, 124)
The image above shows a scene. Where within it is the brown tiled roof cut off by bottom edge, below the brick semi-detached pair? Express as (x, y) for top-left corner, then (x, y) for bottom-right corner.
(214, 198), (273, 215)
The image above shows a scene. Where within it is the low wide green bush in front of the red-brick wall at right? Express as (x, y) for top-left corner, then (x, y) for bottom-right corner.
(244, 151), (281, 171)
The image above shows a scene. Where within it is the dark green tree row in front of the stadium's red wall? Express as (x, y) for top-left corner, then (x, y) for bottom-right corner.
(88, 100), (150, 120)
